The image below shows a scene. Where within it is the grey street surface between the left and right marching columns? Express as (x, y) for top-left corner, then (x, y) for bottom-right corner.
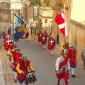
(17, 41), (56, 85)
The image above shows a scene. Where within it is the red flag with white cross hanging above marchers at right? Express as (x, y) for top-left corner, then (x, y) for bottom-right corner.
(55, 12), (68, 38)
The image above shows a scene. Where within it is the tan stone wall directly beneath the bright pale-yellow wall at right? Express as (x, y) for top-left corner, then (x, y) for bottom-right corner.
(70, 20), (85, 57)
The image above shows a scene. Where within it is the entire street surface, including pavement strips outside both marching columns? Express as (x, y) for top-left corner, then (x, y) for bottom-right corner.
(2, 40), (85, 85)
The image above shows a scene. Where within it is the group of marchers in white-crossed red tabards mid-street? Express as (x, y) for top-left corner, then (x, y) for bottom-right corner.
(38, 30), (56, 55)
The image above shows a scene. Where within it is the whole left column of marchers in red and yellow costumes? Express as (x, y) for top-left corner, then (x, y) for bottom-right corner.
(4, 33), (37, 85)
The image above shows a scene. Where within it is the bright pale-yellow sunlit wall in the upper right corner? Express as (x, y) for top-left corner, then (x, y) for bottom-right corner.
(71, 0), (85, 24)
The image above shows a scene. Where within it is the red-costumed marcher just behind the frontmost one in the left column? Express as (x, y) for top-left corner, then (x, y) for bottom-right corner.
(10, 48), (22, 82)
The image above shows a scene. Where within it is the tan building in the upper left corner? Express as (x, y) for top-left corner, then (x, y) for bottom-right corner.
(0, 0), (10, 31)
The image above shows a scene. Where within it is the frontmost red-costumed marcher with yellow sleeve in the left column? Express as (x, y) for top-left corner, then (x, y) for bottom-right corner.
(16, 54), (33, 84)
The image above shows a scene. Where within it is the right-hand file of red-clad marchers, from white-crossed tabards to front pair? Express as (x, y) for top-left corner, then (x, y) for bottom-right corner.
(38, 30), (77, 85)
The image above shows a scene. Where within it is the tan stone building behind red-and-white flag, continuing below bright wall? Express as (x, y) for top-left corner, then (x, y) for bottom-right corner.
(53, 0), (85, 58)
